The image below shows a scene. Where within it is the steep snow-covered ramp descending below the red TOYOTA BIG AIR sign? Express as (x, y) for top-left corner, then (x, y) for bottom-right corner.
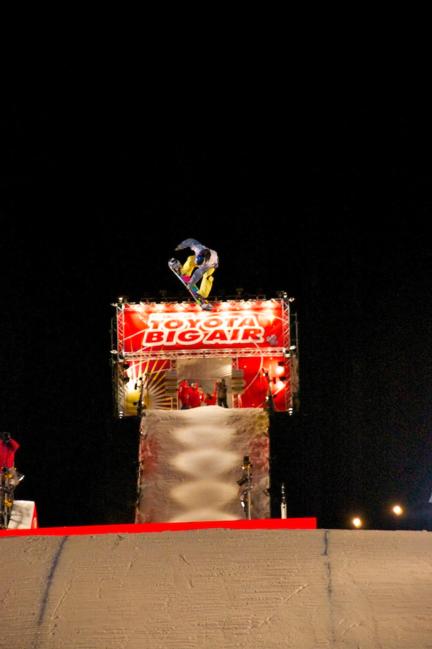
(135, 406), (270, 523)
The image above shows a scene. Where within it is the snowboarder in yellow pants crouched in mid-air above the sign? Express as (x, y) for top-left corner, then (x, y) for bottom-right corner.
(169, 239), (219, 298)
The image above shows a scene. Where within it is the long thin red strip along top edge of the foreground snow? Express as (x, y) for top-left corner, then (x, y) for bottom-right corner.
(0, 517), (317, 537)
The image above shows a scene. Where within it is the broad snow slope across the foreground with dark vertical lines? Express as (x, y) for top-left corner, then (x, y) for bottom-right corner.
(0, 529), (432, 649)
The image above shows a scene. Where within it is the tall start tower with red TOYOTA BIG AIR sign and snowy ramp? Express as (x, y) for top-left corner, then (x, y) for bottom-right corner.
(111, 293), (298, 523)
